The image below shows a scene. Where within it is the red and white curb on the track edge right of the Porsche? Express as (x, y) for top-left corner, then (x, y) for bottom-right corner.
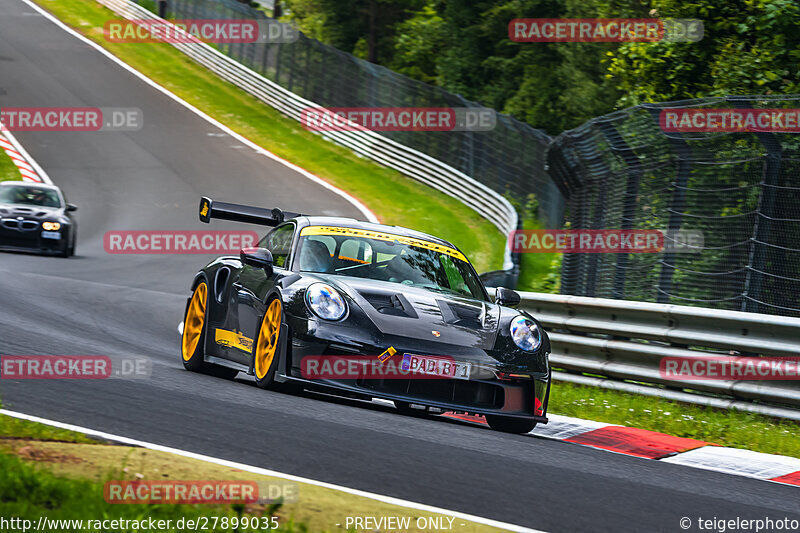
(443, 413), (800, 486)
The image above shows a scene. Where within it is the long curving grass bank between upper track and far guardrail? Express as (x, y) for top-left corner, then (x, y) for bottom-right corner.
(31, 0), (505, 271)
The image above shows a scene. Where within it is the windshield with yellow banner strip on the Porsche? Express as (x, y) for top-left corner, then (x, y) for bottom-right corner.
(298, 226), (485, 300)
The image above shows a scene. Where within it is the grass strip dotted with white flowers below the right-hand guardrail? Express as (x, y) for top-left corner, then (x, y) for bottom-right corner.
(550, 381), (800, 457)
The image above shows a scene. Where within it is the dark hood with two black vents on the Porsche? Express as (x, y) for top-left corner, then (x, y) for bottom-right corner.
(317, 275), (500, 350)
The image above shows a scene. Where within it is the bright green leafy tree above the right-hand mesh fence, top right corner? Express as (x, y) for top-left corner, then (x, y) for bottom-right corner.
(608, 0), (800, 106)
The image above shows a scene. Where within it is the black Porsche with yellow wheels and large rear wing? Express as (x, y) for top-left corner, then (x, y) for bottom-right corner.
(181, 198), (550, 433)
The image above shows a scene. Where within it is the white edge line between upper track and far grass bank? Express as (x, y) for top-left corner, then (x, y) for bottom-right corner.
(21, 0), (380, 223)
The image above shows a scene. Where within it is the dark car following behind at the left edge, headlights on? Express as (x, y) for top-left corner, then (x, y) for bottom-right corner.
(0, 181), (78, 257)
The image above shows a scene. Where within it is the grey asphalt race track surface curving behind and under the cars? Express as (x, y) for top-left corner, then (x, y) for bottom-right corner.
(0, 0), (800, 532)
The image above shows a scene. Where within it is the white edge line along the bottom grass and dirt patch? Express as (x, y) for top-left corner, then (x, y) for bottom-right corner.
(0, 409), (544, 533)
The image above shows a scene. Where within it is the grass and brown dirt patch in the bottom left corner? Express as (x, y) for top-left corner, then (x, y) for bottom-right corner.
(0, 416), (506, 533)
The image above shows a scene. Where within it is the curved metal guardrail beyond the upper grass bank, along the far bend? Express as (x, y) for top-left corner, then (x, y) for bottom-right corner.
(97, 0), (517, 269)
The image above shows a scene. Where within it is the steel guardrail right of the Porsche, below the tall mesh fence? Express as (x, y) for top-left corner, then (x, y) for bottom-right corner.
(520, 292), (800, 420)
